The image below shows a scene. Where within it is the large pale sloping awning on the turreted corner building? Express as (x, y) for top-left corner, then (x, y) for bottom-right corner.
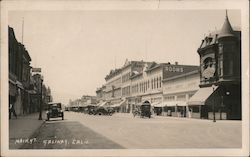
(187, 86), (218, 106)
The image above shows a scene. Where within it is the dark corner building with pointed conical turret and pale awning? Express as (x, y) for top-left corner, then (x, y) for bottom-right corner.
(189, 12), (242, 119)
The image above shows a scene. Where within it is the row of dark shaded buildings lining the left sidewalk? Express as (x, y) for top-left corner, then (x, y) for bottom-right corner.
(8, 27), (51, 115)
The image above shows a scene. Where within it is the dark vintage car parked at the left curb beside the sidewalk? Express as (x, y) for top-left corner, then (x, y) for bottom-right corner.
(46, 102), (64, 120)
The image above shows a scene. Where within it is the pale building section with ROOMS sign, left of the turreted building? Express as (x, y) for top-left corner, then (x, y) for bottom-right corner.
(162, 65), (200, 118)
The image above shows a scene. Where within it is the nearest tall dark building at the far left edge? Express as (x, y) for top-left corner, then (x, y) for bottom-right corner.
(8, 27), (31, 115)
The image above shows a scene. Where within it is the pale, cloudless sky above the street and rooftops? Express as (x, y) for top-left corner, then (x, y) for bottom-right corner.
(8, 10), (241, 104)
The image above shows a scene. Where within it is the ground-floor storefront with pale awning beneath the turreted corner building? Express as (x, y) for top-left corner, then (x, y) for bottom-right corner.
(188, 86), (235, 120)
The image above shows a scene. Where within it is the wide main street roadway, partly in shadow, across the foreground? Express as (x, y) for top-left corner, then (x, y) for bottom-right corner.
(17, 112), (241, 149)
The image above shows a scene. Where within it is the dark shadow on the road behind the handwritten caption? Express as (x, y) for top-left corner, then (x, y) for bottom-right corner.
(17, 120), (123, 149)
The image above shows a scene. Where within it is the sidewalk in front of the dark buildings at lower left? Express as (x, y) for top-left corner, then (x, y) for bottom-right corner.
(9, 112), (46, 149)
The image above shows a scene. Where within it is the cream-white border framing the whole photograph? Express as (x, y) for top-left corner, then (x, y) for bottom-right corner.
(0, 0), (249, 156)
